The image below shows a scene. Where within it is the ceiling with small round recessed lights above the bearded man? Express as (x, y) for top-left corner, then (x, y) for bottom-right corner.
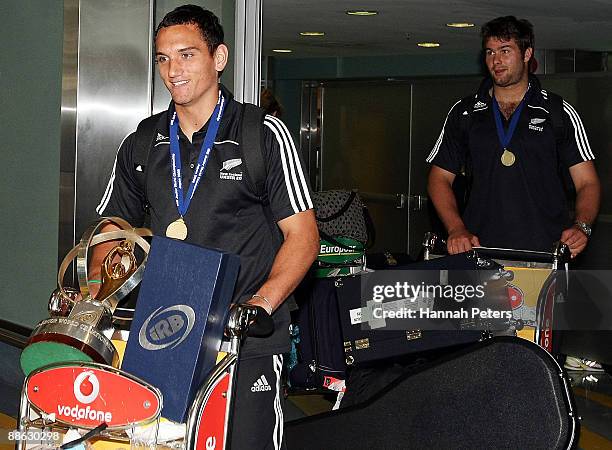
(263, 0), (612, 58)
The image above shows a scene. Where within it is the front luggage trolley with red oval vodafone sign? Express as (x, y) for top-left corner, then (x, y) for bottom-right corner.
(16, 305), (260, 450)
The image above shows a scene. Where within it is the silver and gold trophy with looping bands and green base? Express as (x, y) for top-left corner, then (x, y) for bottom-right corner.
(21, 217), (152, 375)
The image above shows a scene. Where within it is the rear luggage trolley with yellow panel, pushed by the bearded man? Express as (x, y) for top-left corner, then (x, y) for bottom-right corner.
(423, 233), (570, 353)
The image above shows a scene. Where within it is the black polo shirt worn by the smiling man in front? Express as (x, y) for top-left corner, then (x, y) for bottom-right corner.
(96, 85), (312, 357)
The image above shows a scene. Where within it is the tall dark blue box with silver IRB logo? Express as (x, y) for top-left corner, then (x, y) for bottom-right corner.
(121, 236), (240, 422)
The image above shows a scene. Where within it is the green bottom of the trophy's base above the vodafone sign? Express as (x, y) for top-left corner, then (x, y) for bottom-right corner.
(20, 341), (93, 376)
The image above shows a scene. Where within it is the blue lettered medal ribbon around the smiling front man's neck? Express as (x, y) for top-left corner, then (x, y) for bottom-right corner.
(170, 92), (225, 217)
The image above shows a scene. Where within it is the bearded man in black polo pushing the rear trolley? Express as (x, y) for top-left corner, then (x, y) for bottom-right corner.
(427, 16), (601, 371)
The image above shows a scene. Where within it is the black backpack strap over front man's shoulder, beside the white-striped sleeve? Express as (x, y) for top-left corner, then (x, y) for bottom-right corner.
(240, 103), (267, 203)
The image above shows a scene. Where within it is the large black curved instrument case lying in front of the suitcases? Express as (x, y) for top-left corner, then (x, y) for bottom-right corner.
(285, 337), (580, 450)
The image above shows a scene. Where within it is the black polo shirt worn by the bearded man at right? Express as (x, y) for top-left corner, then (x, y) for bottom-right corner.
(427, 75), (595, 251)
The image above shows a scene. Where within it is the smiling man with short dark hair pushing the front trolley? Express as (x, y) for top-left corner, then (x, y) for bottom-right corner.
(90, 5), (319, 449)
